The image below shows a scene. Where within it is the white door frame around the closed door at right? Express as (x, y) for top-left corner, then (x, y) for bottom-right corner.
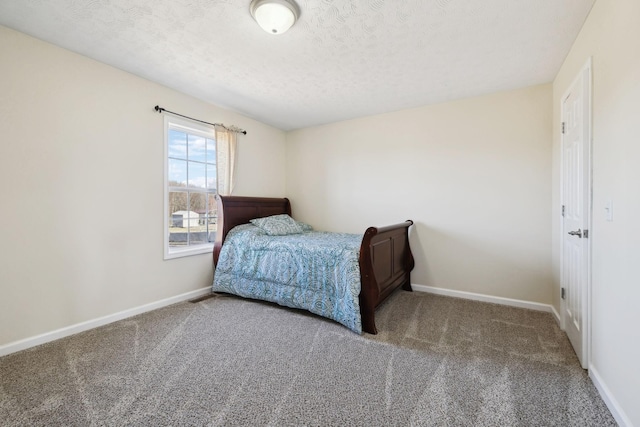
(560, 57), (593, 369)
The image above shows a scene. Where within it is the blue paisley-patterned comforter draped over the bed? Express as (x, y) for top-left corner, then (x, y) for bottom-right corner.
(213, 224), (363, 334)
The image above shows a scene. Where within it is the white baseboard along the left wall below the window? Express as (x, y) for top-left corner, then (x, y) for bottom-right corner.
(0, 286), (211, 357)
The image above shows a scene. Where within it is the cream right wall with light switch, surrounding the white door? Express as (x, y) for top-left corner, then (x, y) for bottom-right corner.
(553, 0), (640, 426)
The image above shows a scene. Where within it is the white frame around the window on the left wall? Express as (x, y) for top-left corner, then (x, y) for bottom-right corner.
(163, 116), (218, 260)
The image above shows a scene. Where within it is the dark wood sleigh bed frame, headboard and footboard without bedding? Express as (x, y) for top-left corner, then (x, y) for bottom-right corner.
(213, 196), (414, 334)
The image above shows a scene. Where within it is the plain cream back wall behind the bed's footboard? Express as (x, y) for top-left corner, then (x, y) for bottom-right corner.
(287, 85), (552, 303)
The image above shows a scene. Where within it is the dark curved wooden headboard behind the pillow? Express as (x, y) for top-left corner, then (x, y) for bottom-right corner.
(213, 196), (291, 266)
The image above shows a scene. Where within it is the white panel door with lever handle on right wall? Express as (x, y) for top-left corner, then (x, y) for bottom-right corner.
(561, 63), (591, 369)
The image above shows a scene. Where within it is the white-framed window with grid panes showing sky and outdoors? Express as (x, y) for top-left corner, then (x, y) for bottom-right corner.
(164, 116), (217, 259)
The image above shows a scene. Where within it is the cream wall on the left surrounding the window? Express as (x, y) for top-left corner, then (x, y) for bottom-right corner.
(0, 27), (285, 346)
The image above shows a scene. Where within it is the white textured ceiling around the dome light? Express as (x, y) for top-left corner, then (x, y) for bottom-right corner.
(0, 0), (595, 130)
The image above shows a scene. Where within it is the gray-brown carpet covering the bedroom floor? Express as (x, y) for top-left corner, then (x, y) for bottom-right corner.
(0, 291), (616, 426)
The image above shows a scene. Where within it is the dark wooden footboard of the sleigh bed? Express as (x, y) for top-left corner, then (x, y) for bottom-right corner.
(359, 220), (415, 334)
